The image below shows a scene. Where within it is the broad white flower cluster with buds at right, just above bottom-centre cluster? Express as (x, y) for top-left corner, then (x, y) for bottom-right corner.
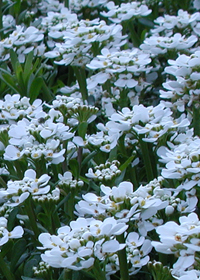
(75, 177), (197, 236)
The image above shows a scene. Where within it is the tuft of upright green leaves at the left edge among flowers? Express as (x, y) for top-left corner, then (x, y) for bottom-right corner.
(0, 49), (54, 103)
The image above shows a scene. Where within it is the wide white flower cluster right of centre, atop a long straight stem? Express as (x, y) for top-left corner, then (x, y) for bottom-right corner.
(104, 103), (190, 143)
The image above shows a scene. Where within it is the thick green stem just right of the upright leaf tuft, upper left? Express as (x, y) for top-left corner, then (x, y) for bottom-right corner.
(73, 66), (88, 101)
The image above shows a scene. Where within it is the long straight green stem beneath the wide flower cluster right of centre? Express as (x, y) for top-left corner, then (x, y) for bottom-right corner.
(139, 135), (155, 182)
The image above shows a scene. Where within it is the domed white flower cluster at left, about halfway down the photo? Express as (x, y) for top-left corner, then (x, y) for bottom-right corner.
(4, 111), (73, 164)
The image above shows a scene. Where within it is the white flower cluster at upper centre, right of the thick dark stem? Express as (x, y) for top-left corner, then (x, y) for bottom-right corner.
(87, 48), (151, 89)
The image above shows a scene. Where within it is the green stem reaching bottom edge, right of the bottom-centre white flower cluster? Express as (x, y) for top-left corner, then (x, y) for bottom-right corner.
(117, 234), (129, 280)
